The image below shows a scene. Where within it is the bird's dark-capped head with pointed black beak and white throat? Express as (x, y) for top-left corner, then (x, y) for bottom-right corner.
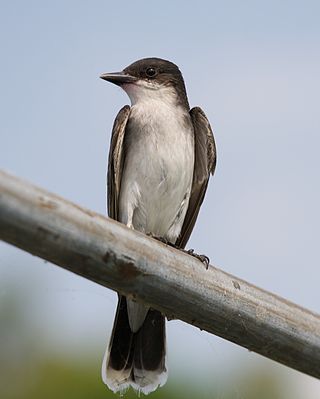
(100, 58), (189, 109)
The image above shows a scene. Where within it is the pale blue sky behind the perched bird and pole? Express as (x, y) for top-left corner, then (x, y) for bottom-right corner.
(0, 0), (320, 399)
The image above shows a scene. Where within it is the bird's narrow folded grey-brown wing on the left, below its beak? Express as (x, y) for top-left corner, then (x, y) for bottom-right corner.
(107, 105), (130, 220)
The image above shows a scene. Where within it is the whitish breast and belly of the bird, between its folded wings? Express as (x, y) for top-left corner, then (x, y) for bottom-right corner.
(119, 96), (194, 242)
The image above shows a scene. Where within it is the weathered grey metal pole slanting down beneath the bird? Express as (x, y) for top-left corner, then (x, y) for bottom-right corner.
(0, 171), (320, 378)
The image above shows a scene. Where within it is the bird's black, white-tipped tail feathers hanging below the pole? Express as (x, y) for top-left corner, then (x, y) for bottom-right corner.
(102, 296), (167, 394)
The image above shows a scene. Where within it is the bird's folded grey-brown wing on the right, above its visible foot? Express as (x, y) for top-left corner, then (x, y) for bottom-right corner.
(176, 107), (217, 248)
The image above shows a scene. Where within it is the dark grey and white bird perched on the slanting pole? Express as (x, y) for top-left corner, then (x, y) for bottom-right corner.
(100, 57), (216, 395)
